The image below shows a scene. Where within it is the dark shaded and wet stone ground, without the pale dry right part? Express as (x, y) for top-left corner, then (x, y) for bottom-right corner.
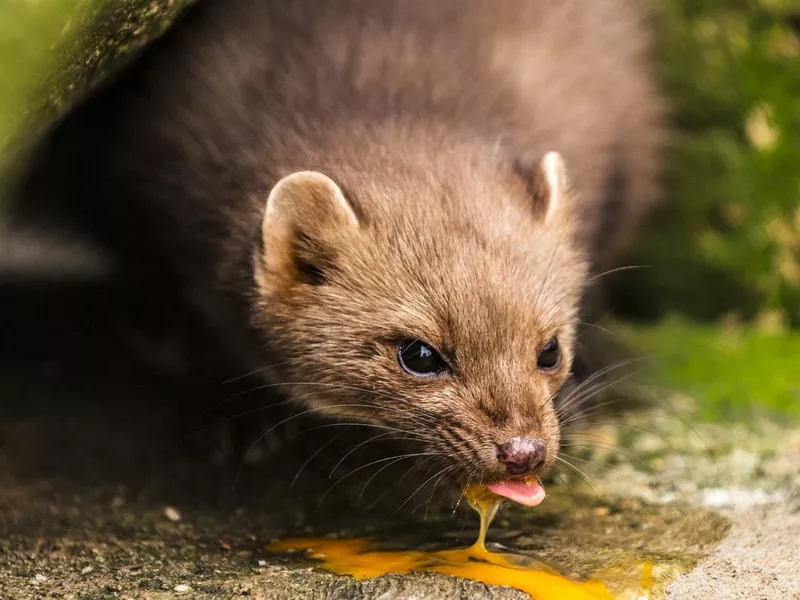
(0, 284), (728, 599)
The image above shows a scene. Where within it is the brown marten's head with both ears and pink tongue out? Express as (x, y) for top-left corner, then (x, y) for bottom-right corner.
(254, 152), (587, 503)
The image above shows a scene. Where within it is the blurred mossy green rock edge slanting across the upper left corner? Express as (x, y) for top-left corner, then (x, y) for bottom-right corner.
(0, 0), (193, 195)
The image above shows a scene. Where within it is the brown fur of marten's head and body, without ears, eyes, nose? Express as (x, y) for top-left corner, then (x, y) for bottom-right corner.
(14, 0), (660, 488)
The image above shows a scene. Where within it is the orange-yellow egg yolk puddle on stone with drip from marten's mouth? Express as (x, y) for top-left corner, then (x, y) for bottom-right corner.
(269, 487), (644, 600)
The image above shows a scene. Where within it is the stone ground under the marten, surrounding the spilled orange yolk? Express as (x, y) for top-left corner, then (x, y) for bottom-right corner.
(0, 236), (800, 600)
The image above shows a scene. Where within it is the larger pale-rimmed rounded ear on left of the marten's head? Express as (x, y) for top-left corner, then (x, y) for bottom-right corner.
(257, 171), (359, 289)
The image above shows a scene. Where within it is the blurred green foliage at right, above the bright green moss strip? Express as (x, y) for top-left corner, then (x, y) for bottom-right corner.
(623, 0), (800, 327)
